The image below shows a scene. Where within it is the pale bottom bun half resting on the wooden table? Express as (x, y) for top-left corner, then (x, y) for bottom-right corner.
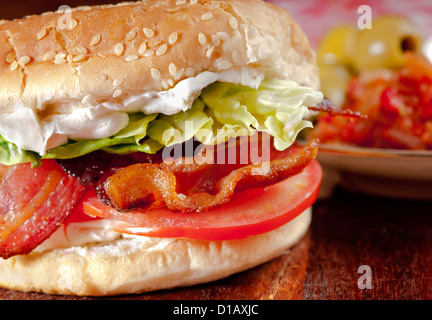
(0, 208), (312, 296)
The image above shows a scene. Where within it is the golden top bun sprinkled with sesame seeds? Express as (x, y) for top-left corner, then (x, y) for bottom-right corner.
(0, 0), (319, 115)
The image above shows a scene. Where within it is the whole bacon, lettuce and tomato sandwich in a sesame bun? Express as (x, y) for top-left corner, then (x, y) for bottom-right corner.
(0, 0), (325, 296)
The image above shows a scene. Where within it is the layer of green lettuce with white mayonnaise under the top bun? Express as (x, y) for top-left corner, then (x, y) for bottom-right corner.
(0, 67), (323, 166)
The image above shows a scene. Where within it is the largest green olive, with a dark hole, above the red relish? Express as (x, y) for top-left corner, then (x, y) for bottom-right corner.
(353, 15), (422, 72)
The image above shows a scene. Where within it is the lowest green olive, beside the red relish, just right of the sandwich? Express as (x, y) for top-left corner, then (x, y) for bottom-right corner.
(319, 63), (352, 107)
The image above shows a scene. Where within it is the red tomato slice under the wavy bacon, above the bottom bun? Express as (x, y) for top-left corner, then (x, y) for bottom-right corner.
(83, 160), (322, 241)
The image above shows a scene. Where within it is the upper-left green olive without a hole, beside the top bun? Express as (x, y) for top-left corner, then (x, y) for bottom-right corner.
(317, 26), (357, 65)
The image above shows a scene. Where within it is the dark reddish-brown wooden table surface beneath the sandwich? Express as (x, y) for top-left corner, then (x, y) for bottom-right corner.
(0, 189), (432, 300)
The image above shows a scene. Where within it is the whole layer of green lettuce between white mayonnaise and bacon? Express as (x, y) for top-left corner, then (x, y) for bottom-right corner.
(0, 79), (322, 165)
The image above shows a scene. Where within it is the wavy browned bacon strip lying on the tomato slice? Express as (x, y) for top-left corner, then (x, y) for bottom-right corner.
(104, 140), (318, 212)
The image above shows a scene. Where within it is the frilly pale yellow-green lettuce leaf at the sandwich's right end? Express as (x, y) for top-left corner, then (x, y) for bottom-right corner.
(200, 79), (323, 150)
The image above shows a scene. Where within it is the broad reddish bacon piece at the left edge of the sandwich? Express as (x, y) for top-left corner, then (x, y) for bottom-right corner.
(0, 160), (85, 259)
